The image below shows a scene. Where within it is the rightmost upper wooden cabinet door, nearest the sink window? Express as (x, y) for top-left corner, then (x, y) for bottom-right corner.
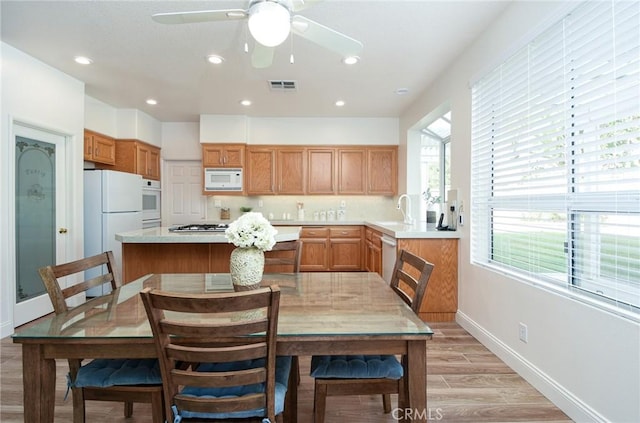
(367, 147), (398, 195)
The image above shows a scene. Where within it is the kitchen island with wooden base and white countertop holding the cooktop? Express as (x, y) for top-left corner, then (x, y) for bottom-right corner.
(116, 226), (301, 283)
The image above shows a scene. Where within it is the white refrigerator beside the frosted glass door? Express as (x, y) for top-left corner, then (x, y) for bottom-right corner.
(84, 169), (142, 296)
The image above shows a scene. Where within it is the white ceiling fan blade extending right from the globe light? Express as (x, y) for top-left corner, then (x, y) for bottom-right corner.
(291, 15), (364, 57)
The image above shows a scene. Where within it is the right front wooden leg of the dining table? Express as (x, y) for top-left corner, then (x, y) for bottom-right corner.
(408, 340), (429, 422)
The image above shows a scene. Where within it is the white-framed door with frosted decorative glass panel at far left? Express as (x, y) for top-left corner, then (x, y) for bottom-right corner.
(12, 123), (69, 326)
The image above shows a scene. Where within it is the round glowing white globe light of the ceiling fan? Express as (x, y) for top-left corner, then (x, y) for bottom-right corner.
(248, 1), (291, 47)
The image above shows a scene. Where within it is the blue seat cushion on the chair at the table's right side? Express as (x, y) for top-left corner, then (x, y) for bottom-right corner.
(310, 355), (404, 379)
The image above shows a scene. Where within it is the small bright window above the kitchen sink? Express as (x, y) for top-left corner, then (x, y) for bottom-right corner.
(420, 111), (451, 220)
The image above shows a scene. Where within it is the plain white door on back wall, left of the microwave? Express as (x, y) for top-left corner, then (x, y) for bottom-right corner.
(162, 160), (207, 226)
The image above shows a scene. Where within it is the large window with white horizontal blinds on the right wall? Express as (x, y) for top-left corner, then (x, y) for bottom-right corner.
(471, 1), (640, 314)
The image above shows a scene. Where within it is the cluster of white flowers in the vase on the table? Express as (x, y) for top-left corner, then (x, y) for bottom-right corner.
(224, 212), (278, 251)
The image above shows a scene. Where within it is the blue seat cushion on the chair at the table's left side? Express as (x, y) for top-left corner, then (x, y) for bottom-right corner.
(71, 359), (162, 388)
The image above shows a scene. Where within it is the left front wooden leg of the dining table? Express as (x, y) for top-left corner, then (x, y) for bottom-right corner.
(22, 344), (56, 423)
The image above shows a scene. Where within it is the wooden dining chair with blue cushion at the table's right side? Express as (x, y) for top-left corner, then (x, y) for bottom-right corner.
(310, 250), (433, 423)
